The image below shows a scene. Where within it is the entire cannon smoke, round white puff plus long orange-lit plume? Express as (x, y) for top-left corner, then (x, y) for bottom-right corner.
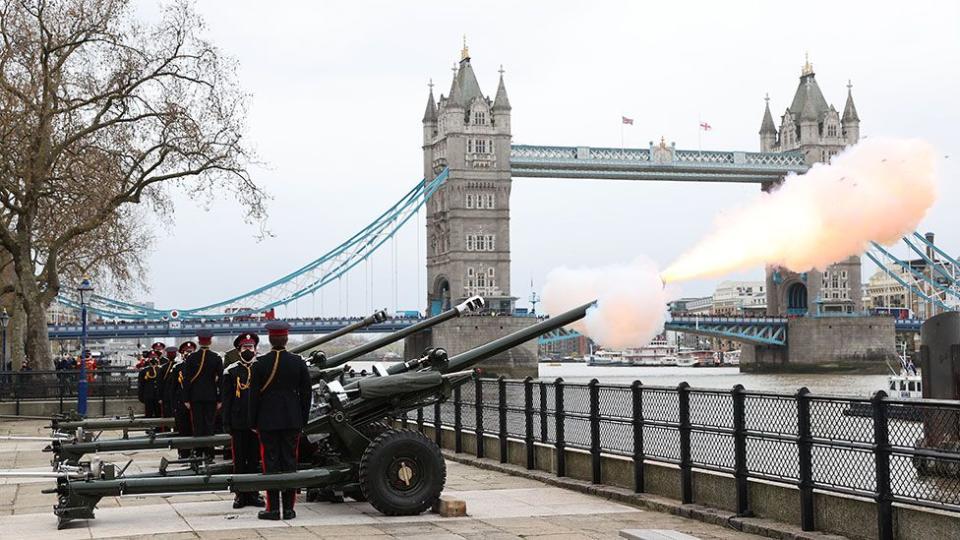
(543, 139), (937, 348)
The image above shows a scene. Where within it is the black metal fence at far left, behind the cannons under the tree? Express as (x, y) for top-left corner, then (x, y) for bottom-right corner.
(0, 368), (137, 414)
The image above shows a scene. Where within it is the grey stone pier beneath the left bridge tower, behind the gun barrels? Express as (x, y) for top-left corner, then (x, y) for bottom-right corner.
(404, 316), (537, 379)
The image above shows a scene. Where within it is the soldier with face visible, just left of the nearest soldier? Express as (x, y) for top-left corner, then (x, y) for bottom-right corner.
(220, 333), (263, 508)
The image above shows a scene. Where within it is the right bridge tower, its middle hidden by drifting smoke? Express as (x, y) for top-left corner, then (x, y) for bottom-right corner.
(760, 54), (863, 315)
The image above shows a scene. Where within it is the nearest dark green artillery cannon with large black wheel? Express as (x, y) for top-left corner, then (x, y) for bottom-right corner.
(48, 303), (592, 528)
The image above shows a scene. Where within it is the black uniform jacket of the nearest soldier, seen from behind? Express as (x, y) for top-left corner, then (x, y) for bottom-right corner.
(250, 349), (311, 431)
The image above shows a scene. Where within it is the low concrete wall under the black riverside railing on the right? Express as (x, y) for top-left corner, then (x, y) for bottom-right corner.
(410, 424), (960, 540)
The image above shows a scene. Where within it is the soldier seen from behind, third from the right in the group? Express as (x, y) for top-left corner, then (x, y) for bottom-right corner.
(183, 330), (223, 459)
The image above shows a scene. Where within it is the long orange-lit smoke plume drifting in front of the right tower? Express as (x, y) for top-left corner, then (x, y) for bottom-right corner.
(663, 138), (937, 282)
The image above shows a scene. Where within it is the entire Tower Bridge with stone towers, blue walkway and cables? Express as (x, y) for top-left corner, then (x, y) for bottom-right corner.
(51, 46), (956, 373)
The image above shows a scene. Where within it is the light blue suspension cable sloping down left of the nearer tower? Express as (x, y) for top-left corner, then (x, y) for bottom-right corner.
(57, 169), (449, 320)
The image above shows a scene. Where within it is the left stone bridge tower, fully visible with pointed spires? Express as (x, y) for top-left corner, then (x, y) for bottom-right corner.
(423, 42), (516, 313)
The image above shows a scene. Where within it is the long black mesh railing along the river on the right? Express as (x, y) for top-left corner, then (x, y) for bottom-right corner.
(403, 378), (960, 538)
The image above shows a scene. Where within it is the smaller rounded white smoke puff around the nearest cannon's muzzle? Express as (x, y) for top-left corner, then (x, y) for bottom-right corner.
(543, 258), (669, 349)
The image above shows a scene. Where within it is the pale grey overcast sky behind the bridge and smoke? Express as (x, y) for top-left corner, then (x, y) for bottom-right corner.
(131, 0), (960, 316)
